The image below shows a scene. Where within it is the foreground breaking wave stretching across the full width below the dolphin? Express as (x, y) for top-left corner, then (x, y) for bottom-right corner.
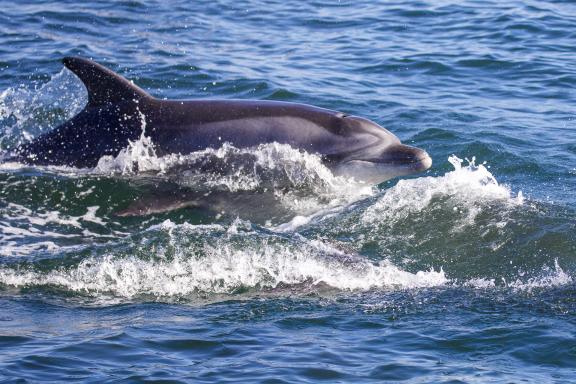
(0, 214), (573, 302)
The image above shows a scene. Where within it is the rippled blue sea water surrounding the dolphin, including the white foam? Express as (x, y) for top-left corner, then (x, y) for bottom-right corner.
(0, 1), (576, 383)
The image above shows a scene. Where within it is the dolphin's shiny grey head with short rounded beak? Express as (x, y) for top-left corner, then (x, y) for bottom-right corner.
(332, 115), (432, 184)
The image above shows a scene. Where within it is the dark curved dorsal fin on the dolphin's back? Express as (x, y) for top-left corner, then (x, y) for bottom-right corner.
(62, 57), (151, 107)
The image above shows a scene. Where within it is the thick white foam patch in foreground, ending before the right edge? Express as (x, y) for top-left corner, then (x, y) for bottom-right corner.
(0, 221), (447, 298)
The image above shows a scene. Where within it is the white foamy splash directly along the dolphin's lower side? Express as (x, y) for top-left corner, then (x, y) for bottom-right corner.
(94, 123), (374, 215)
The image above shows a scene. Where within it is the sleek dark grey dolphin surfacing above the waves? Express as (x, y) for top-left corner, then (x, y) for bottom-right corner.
(12, 57), (432, 184)
